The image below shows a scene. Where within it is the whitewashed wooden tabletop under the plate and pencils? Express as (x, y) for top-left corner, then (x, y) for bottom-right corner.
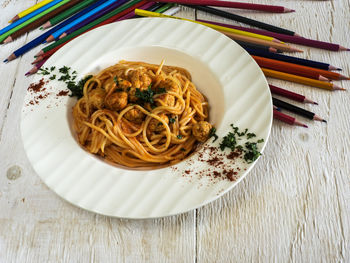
(0, 0), (350, 263)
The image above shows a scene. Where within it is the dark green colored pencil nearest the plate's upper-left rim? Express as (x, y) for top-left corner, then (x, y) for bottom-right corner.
(42, 0), (141, 53)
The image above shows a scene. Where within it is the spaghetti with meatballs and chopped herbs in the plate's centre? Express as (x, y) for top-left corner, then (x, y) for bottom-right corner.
(73, 61), (212, 167)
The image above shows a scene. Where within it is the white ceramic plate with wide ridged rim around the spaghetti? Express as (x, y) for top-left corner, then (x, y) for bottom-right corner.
(21, 18), (272, 218)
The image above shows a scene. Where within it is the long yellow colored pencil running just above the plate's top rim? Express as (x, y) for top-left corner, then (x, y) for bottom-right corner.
(135, 9), (283, 43)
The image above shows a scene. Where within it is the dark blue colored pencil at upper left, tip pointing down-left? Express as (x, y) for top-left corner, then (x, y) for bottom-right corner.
(4, 0), (107, 62)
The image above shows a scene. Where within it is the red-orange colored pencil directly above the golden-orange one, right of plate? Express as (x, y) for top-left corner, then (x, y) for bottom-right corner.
(252, 55), (350, 81)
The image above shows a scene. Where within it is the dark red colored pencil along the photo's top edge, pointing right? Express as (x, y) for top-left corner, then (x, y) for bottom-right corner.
(146, 0), (295, 13)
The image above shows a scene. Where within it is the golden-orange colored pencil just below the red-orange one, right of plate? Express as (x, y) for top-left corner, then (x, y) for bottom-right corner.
(261, 68), (345, 90)
